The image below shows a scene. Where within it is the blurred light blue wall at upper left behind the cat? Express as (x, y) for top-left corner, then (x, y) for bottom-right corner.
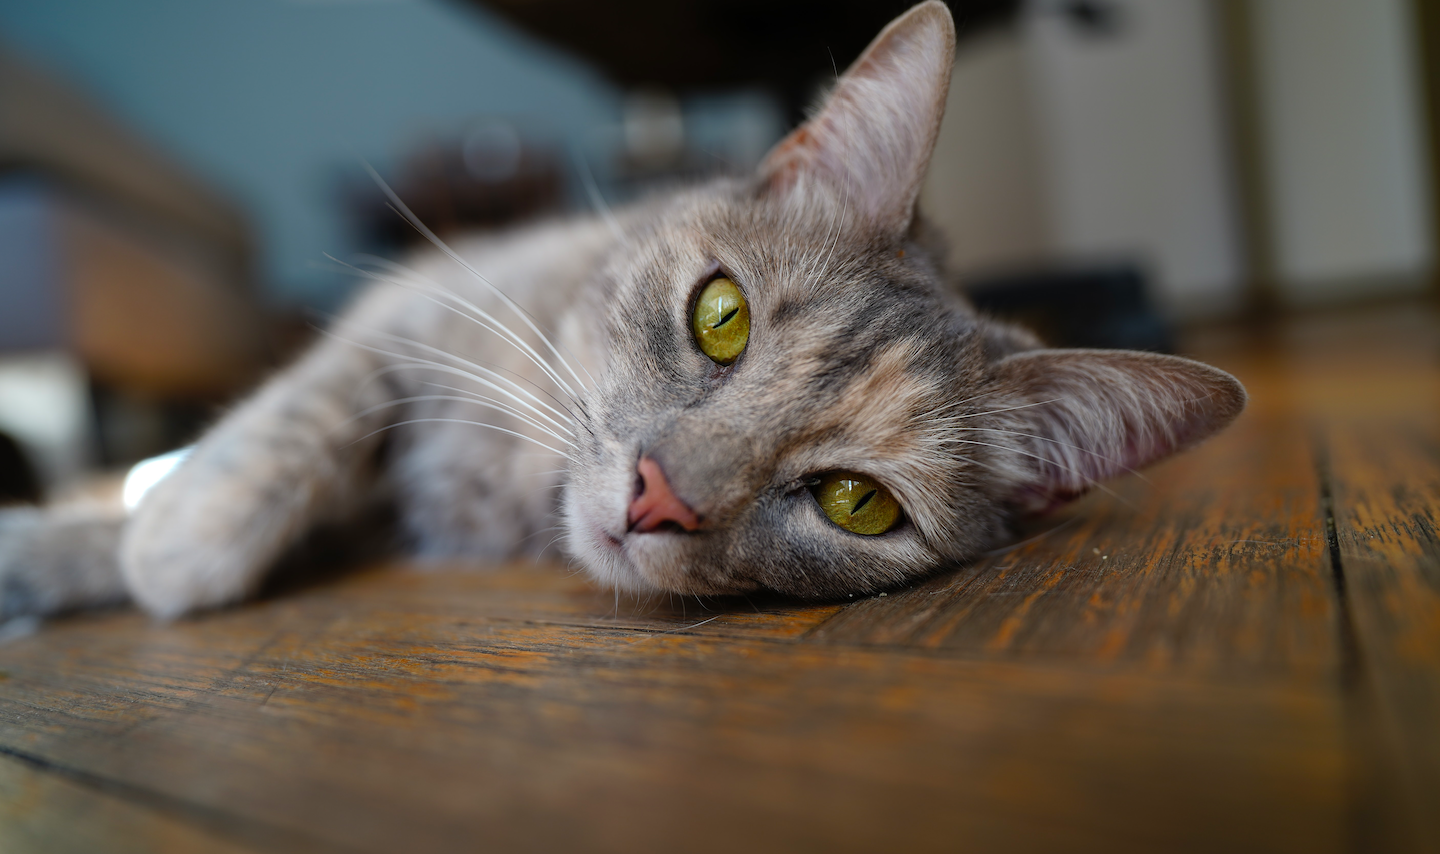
(0, 0), (621, 307)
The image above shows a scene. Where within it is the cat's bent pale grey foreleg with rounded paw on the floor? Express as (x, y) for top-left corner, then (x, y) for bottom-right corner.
(120, 341), (395, 618)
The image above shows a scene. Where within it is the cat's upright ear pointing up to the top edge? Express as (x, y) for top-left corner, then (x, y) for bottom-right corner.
(760, 0), (955, 235)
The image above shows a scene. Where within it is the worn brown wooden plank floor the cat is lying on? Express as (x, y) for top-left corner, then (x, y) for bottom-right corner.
(0, 305), (1440, 854)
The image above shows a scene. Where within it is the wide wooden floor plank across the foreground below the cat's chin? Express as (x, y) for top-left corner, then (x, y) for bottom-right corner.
(0, 599), (1346, 851)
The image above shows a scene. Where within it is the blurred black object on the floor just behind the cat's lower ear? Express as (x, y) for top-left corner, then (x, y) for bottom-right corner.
(965, 262), (1175, 353)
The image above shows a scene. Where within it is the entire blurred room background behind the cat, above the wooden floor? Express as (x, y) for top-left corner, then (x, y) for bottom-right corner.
(0, 0), (1440, 500)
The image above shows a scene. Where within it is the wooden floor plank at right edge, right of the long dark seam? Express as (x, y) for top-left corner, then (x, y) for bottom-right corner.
(1328, 388), (1440, 851)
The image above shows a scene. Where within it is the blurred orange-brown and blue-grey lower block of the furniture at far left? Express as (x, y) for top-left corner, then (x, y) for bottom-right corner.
(0, 174), (261, 397)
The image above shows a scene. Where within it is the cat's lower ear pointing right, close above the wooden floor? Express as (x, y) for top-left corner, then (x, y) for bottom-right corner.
(985, 350), (1247, 513)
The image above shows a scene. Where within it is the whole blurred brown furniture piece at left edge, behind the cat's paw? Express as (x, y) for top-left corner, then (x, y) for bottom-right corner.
(0, 50), (266, 480)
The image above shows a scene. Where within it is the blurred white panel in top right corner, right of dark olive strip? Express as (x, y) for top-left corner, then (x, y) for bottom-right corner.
(1251, 0), (1433, 302)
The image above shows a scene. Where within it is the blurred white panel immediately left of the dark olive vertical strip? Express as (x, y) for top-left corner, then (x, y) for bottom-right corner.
(1027, 0), (1244, 315)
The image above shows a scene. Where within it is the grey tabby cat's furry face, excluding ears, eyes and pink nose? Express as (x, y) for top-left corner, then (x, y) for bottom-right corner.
(566, 177), (1001, 596)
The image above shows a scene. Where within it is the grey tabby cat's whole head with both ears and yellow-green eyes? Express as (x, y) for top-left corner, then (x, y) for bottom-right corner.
(564, 0), (1246, 598)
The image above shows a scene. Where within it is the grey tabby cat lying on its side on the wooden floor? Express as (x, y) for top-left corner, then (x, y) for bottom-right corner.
(0, 0), (1246, 618)
